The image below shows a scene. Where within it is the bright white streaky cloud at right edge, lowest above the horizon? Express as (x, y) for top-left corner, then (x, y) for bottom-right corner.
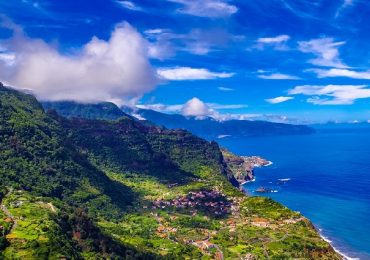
(289, 85), (370, 105)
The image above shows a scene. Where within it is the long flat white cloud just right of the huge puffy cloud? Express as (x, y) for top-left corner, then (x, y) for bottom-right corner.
(158, 67), (234, 80)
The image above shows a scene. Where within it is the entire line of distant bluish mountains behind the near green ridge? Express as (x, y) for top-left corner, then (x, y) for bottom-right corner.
(42, 101), (315, 139)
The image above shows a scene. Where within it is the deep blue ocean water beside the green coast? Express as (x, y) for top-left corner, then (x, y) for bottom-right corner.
(218, 129), (370, 259)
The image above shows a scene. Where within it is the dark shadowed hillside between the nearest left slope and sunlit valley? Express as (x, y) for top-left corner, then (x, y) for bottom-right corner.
(62, 119), (196, 184)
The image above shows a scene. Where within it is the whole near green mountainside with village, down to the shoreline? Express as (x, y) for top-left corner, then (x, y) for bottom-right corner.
(0, 86), (340, 259)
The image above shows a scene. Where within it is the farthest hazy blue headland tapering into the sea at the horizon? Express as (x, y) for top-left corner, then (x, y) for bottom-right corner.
(132, 109), (315, 138)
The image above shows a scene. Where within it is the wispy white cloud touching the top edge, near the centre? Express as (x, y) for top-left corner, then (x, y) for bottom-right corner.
(168, 0), (238, 18)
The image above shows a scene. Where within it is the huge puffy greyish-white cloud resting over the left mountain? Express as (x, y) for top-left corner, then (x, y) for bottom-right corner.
(0, 23), (158, 103)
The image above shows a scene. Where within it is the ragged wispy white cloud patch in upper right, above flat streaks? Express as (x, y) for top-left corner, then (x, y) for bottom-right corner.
(298, 38), (348, 68)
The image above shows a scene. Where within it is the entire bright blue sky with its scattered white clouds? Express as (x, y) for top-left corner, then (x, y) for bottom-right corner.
(0, 0), (370, 123)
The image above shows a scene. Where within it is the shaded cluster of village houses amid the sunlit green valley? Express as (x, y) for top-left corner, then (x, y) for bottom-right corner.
(153, 190), (232, 216)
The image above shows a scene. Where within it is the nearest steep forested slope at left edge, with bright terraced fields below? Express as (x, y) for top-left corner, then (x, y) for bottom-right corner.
(0, 87), (155, 258)
